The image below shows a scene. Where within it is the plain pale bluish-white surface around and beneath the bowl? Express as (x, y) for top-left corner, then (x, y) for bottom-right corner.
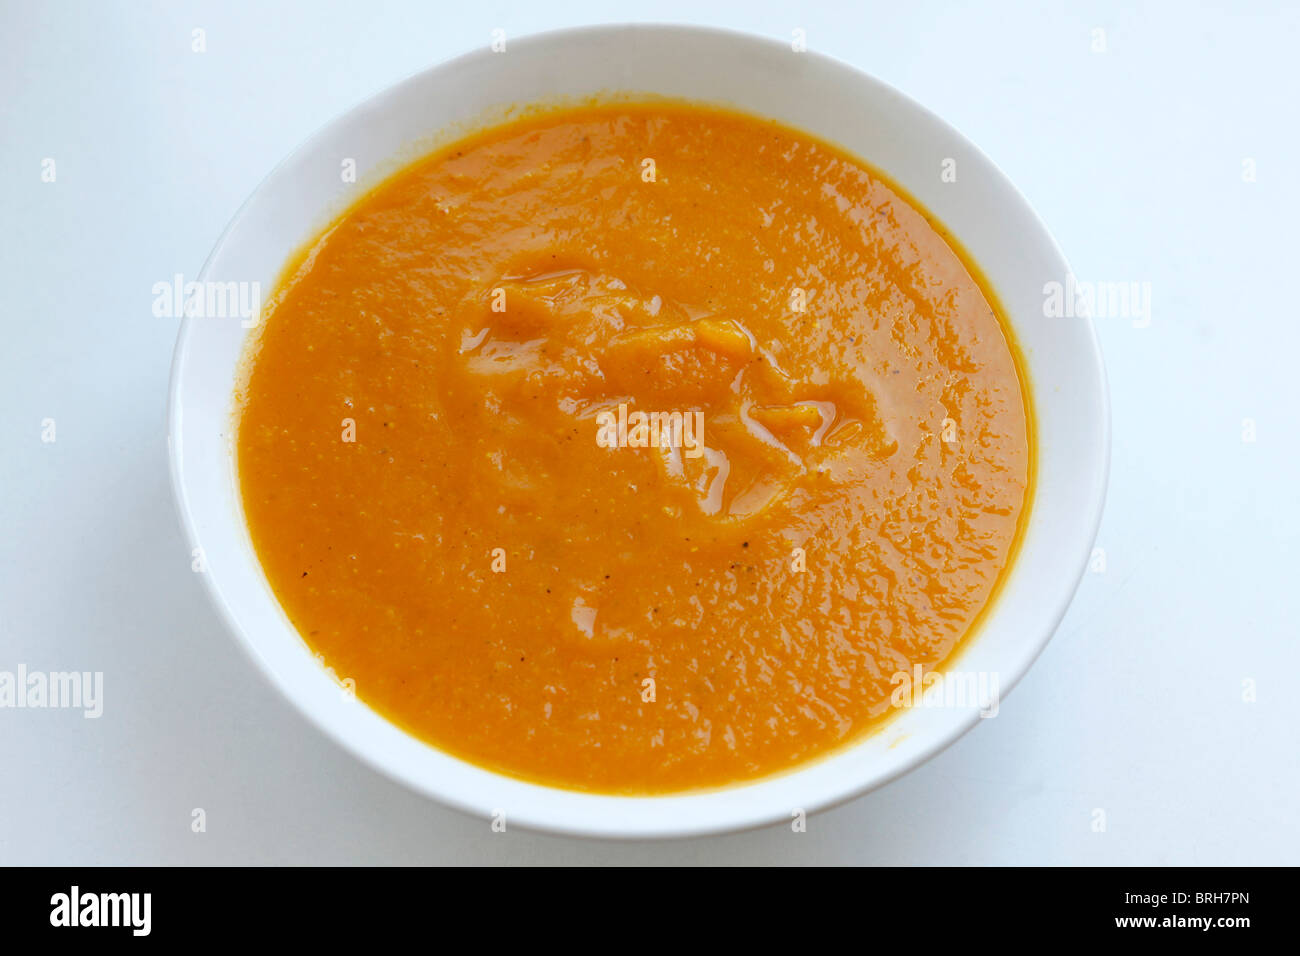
(0, 0), (1300, 864)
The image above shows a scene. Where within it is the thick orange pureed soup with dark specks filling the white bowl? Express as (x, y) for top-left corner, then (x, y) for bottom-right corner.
(238, 103), (1032, 793)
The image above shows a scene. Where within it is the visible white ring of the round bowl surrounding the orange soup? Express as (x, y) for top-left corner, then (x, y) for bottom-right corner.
(169, 26), (1110, 838)
